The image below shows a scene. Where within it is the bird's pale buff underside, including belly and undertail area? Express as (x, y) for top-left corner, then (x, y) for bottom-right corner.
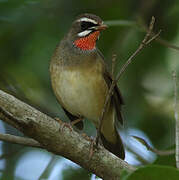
(52, 62), (116, 142)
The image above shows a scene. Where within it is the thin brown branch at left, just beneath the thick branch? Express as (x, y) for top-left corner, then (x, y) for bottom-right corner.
(0, 134), (42, 148)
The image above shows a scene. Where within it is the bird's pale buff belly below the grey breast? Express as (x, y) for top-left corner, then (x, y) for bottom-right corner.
(56, 70), (108, 124)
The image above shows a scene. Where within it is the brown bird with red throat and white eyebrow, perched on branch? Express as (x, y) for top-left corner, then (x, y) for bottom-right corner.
(49, 13), (125, 159)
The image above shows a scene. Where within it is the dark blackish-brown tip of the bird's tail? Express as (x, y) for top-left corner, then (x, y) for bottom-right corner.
(100, 128), (125, 159)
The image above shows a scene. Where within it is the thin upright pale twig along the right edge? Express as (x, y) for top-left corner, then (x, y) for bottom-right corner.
(173, 71), (179, 169)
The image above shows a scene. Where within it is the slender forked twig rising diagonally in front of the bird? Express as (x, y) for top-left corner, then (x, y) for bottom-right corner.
(96, 17), (161, 145)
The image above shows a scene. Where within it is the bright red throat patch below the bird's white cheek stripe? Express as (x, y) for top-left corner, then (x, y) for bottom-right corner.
(74, 31), (100, 50)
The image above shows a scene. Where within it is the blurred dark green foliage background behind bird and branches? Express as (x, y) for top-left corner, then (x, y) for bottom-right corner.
(0, 0), (179, 180)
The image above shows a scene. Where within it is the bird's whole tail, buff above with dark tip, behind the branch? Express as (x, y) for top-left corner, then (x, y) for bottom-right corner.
(100, 108), (125, 159)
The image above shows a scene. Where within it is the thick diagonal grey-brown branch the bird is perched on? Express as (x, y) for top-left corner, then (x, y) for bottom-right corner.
(0, 90), (135, 179)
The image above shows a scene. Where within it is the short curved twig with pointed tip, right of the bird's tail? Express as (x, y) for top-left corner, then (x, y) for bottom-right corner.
(132, 136), (175, 156)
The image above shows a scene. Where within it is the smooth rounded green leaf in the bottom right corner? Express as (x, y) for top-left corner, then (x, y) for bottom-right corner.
(123, 165), (179, 180)
